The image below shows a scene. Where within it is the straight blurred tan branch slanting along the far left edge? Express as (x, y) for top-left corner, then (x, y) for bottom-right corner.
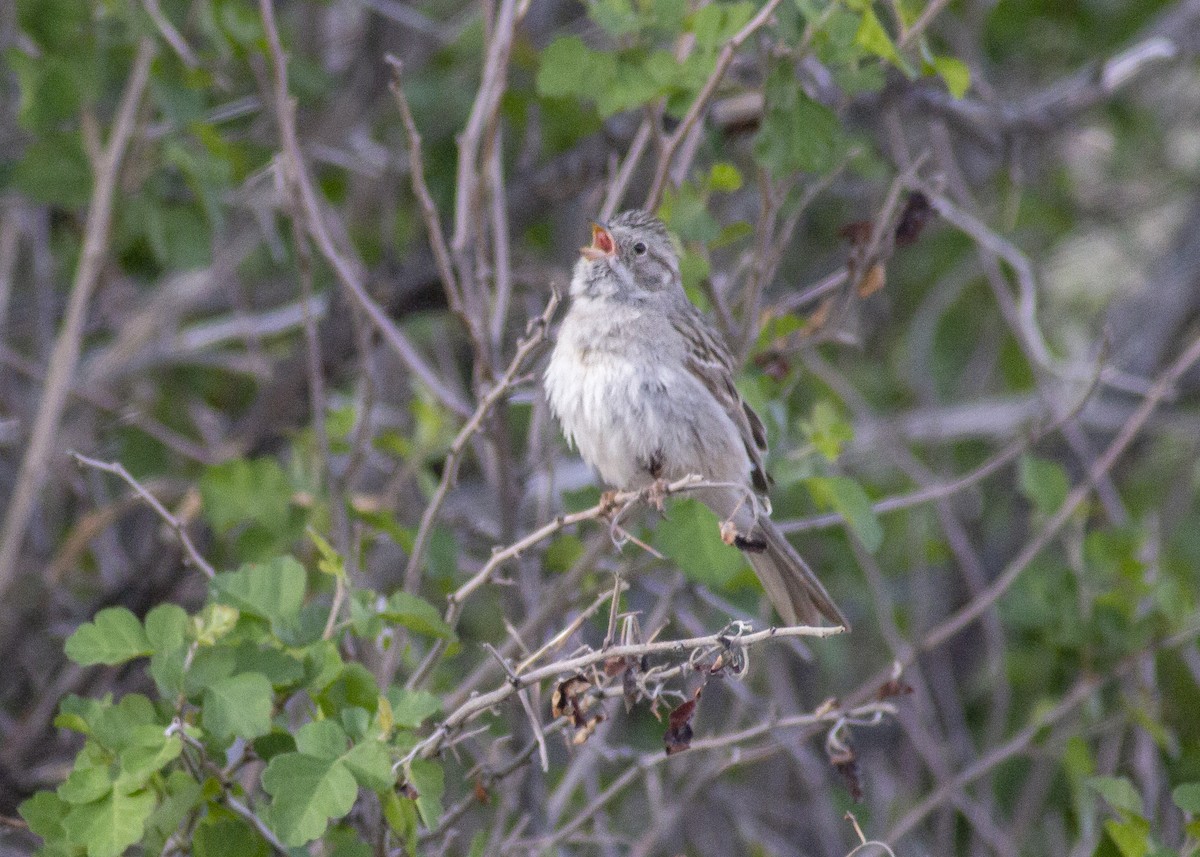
(0, 38), (155, 599)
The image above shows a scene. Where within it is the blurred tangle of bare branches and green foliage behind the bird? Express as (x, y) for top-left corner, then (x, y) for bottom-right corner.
(0, 0), (1200, 857)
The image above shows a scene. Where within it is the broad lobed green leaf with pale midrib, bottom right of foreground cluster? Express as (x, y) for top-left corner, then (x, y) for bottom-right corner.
(263, 753), (359, 846)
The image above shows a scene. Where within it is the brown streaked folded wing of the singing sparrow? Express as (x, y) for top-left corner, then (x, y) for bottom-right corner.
(674, 307), (769, 496)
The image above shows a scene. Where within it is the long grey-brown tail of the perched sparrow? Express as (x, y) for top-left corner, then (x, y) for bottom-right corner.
(743, 517), (850, 631)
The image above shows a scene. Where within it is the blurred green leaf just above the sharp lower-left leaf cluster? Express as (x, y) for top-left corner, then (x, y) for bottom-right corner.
(200, 459), (292, 532)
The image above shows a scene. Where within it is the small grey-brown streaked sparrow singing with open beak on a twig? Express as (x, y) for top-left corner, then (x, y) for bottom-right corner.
(546, 211), (850, 628)
